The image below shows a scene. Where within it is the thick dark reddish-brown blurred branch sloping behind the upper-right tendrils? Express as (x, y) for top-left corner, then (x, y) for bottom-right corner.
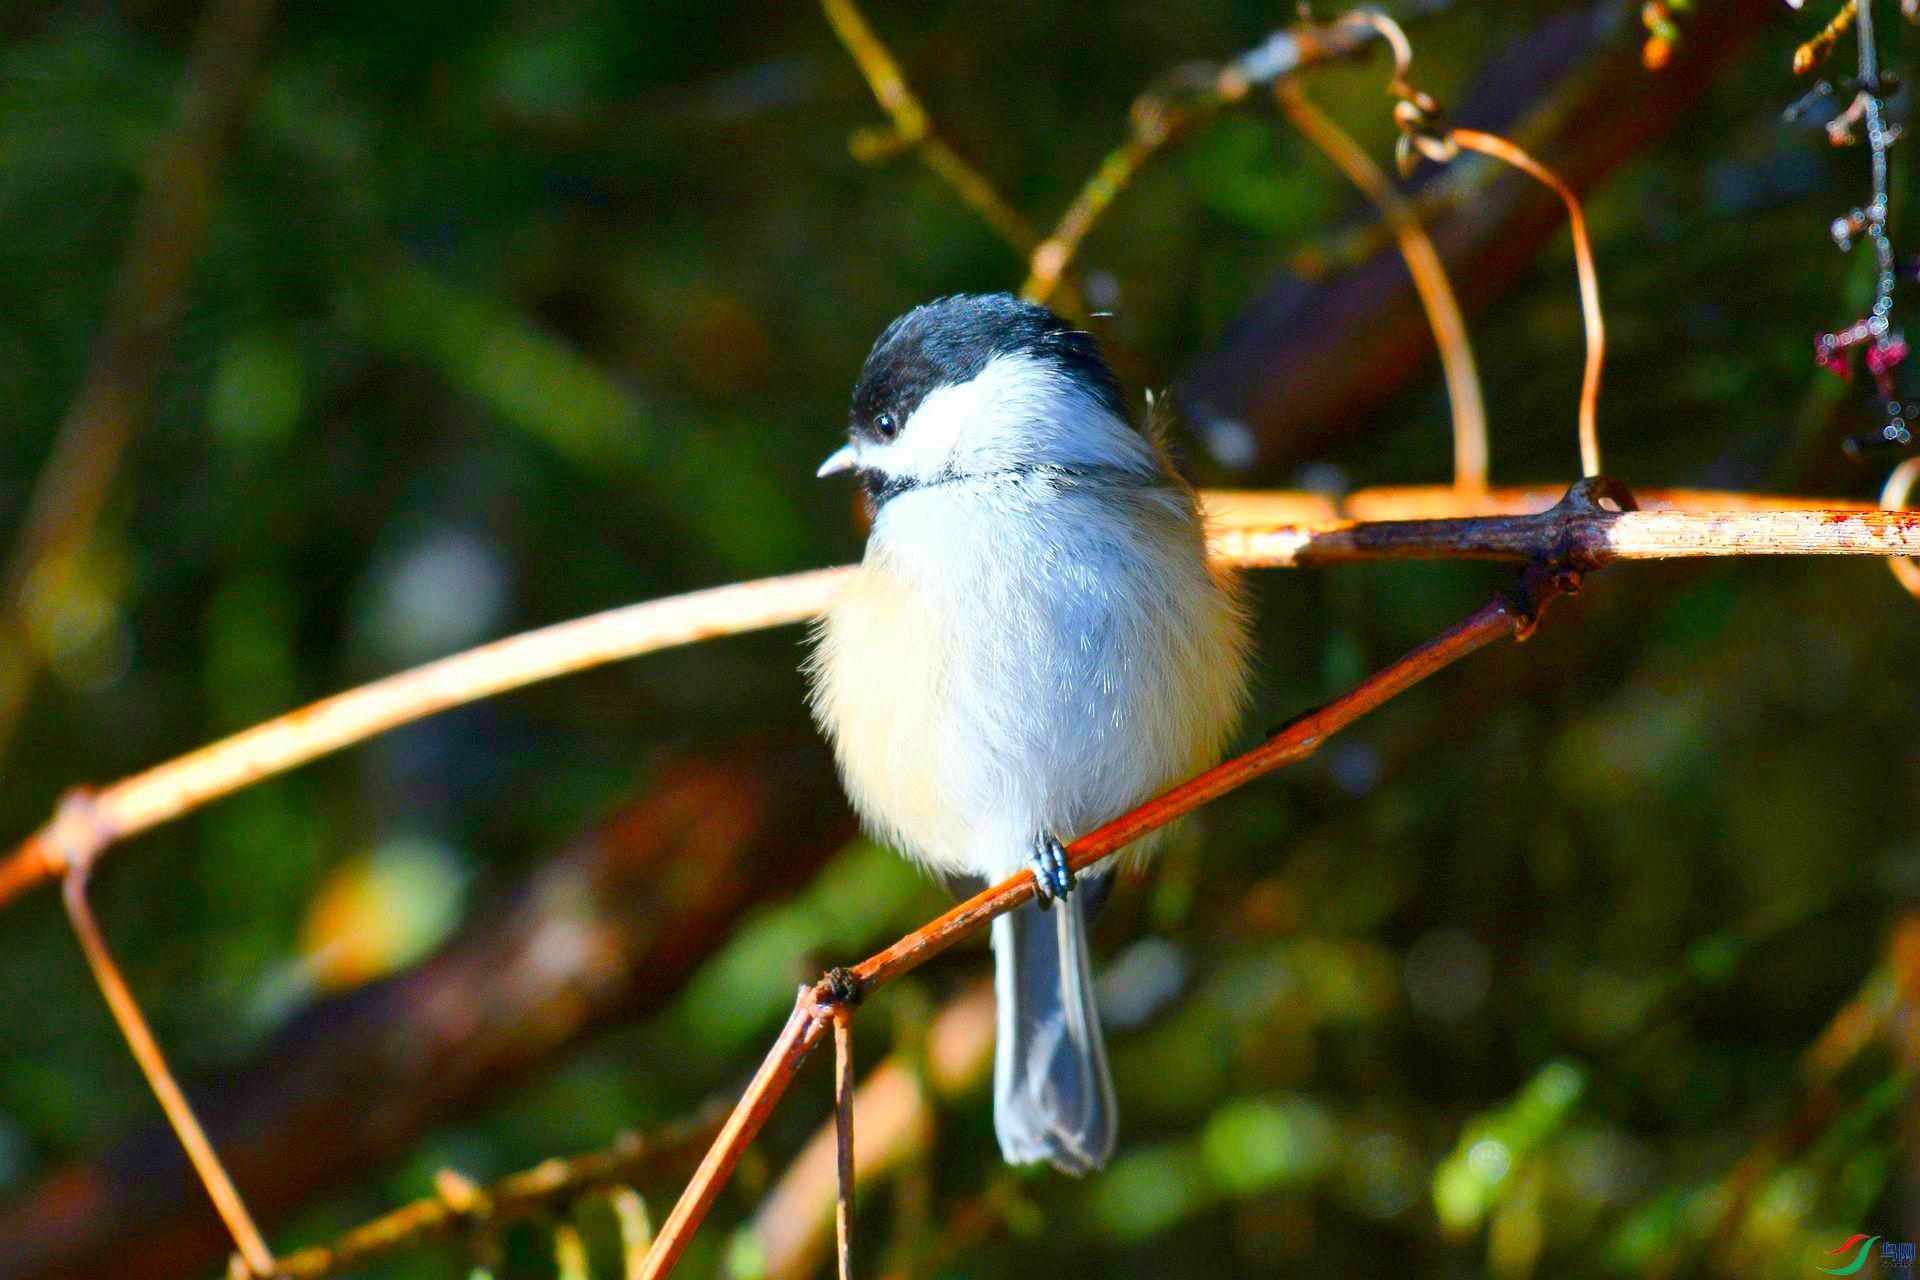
(1179, 0), (1778, 468)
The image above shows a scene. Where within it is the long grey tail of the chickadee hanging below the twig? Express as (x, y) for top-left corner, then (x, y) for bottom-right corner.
(993, 892), (1117, 1174)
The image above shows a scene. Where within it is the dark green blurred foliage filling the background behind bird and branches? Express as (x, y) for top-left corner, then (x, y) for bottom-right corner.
(0, 0), (1920, 1278)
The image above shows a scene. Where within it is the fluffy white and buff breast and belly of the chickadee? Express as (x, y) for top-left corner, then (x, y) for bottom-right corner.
(814, 495), (1244, 877)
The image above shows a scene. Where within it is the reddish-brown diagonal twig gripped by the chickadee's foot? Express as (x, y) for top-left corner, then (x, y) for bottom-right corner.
(641, 556), (1578, 1280)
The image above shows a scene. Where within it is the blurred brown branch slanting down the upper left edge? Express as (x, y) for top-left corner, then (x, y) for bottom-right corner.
(0, 0), (276, 752)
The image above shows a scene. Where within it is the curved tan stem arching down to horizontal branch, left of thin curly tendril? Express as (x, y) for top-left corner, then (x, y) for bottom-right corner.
(1275, 81), (1488, 493)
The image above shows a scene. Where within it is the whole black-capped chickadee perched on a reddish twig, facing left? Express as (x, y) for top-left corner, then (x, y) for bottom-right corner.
(808, 294), (1248, 1174)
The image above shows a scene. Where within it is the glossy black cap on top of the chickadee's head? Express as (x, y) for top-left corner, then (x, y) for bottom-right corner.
(849, 294), (1127, 439)
